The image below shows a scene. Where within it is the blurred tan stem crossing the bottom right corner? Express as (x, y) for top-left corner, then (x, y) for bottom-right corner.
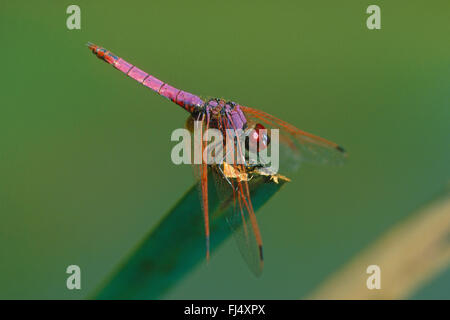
(309, 192), (450, 299)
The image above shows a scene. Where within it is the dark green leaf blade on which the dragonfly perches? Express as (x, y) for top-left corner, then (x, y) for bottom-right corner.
(95, 172), (285, 299)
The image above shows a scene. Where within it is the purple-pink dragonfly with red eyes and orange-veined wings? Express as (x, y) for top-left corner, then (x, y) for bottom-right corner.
(87, 42), (347, 276)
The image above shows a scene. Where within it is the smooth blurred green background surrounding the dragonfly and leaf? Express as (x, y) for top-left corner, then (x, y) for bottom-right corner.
(0, 0), (450, 299)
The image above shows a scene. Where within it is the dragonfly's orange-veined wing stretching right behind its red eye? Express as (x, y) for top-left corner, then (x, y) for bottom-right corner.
(241, 106), (346, 170)
